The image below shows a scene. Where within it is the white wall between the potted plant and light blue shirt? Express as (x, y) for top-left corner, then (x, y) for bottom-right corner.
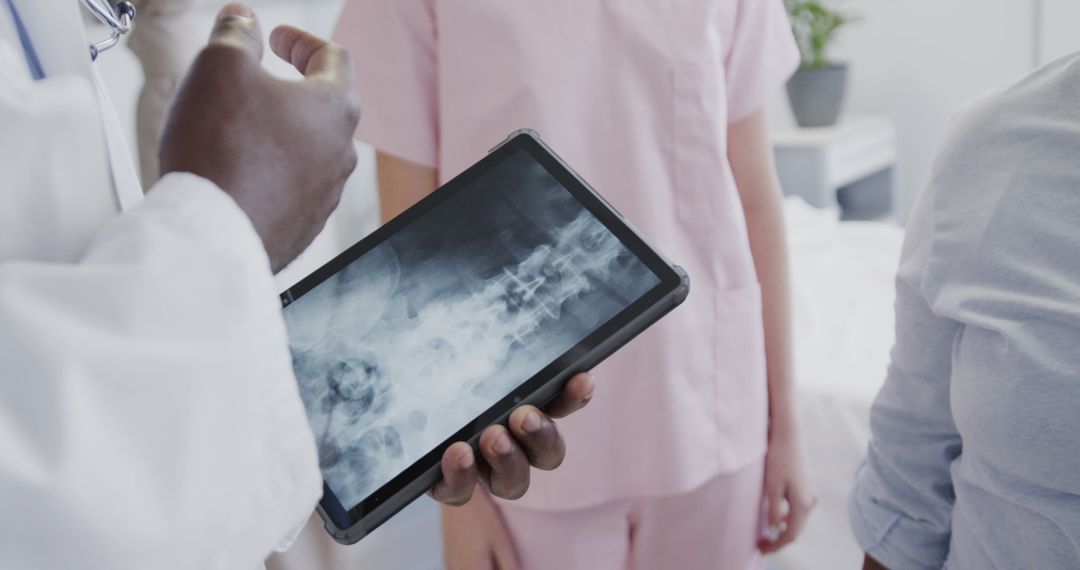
(773, 0), (1045, 219)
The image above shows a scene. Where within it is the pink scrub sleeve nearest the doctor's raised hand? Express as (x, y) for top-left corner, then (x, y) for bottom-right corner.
(334, 0), (438, 167)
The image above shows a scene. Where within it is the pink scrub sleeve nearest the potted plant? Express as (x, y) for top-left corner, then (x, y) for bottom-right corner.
(725, 0), (799, 123)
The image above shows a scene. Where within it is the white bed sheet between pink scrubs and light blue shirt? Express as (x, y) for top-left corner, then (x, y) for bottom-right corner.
(770, 198), (903, 570)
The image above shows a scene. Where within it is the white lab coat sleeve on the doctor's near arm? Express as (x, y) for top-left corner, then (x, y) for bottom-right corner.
(0, 174), (321, 569)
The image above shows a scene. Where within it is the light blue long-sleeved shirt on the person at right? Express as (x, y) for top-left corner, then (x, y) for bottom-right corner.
(850, 56), (1080, 570)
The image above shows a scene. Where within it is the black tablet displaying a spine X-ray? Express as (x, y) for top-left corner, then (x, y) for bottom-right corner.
(281, 131), (689, 544)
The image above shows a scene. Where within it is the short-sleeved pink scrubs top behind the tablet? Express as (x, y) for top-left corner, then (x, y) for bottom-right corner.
(336, 0), (798, 510)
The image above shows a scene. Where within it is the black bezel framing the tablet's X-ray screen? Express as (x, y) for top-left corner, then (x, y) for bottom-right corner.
(281, 132), (685, 529)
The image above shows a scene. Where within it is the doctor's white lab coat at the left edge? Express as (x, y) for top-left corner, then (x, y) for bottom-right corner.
(0, 0), (321, 570)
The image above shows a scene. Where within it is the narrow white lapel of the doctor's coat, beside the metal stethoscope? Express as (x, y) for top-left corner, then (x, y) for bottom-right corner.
(14, 0), (143, 211)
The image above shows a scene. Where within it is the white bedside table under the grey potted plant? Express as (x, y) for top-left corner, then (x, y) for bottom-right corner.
(771, 117), (896, 219)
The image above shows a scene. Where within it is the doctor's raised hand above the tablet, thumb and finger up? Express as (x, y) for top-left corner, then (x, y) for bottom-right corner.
(160, 4), (360, 272)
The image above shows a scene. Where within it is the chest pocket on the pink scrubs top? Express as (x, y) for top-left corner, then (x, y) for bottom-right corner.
(672, 62), (727, 219)
